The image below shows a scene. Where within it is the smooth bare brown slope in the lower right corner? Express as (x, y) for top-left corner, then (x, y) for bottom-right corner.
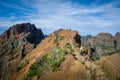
(100, 53), (120, 80)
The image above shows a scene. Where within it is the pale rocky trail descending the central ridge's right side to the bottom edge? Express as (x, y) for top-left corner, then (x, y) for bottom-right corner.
(70, 41), (109, 80)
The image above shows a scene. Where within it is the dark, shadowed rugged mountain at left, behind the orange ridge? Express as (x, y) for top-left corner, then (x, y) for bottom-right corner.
(0, 23), (44, 80)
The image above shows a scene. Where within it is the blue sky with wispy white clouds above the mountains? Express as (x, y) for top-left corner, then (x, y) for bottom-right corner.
(0, 0), (120, 35)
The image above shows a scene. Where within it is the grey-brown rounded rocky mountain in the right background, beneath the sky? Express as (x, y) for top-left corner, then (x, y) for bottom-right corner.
(84, 33), (117, 57)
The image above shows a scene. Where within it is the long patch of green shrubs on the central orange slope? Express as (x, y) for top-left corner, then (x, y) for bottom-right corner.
(24, 43), (73, 80)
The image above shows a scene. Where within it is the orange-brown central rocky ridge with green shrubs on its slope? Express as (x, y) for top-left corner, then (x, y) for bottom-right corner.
(10, 30), (82, 80)
